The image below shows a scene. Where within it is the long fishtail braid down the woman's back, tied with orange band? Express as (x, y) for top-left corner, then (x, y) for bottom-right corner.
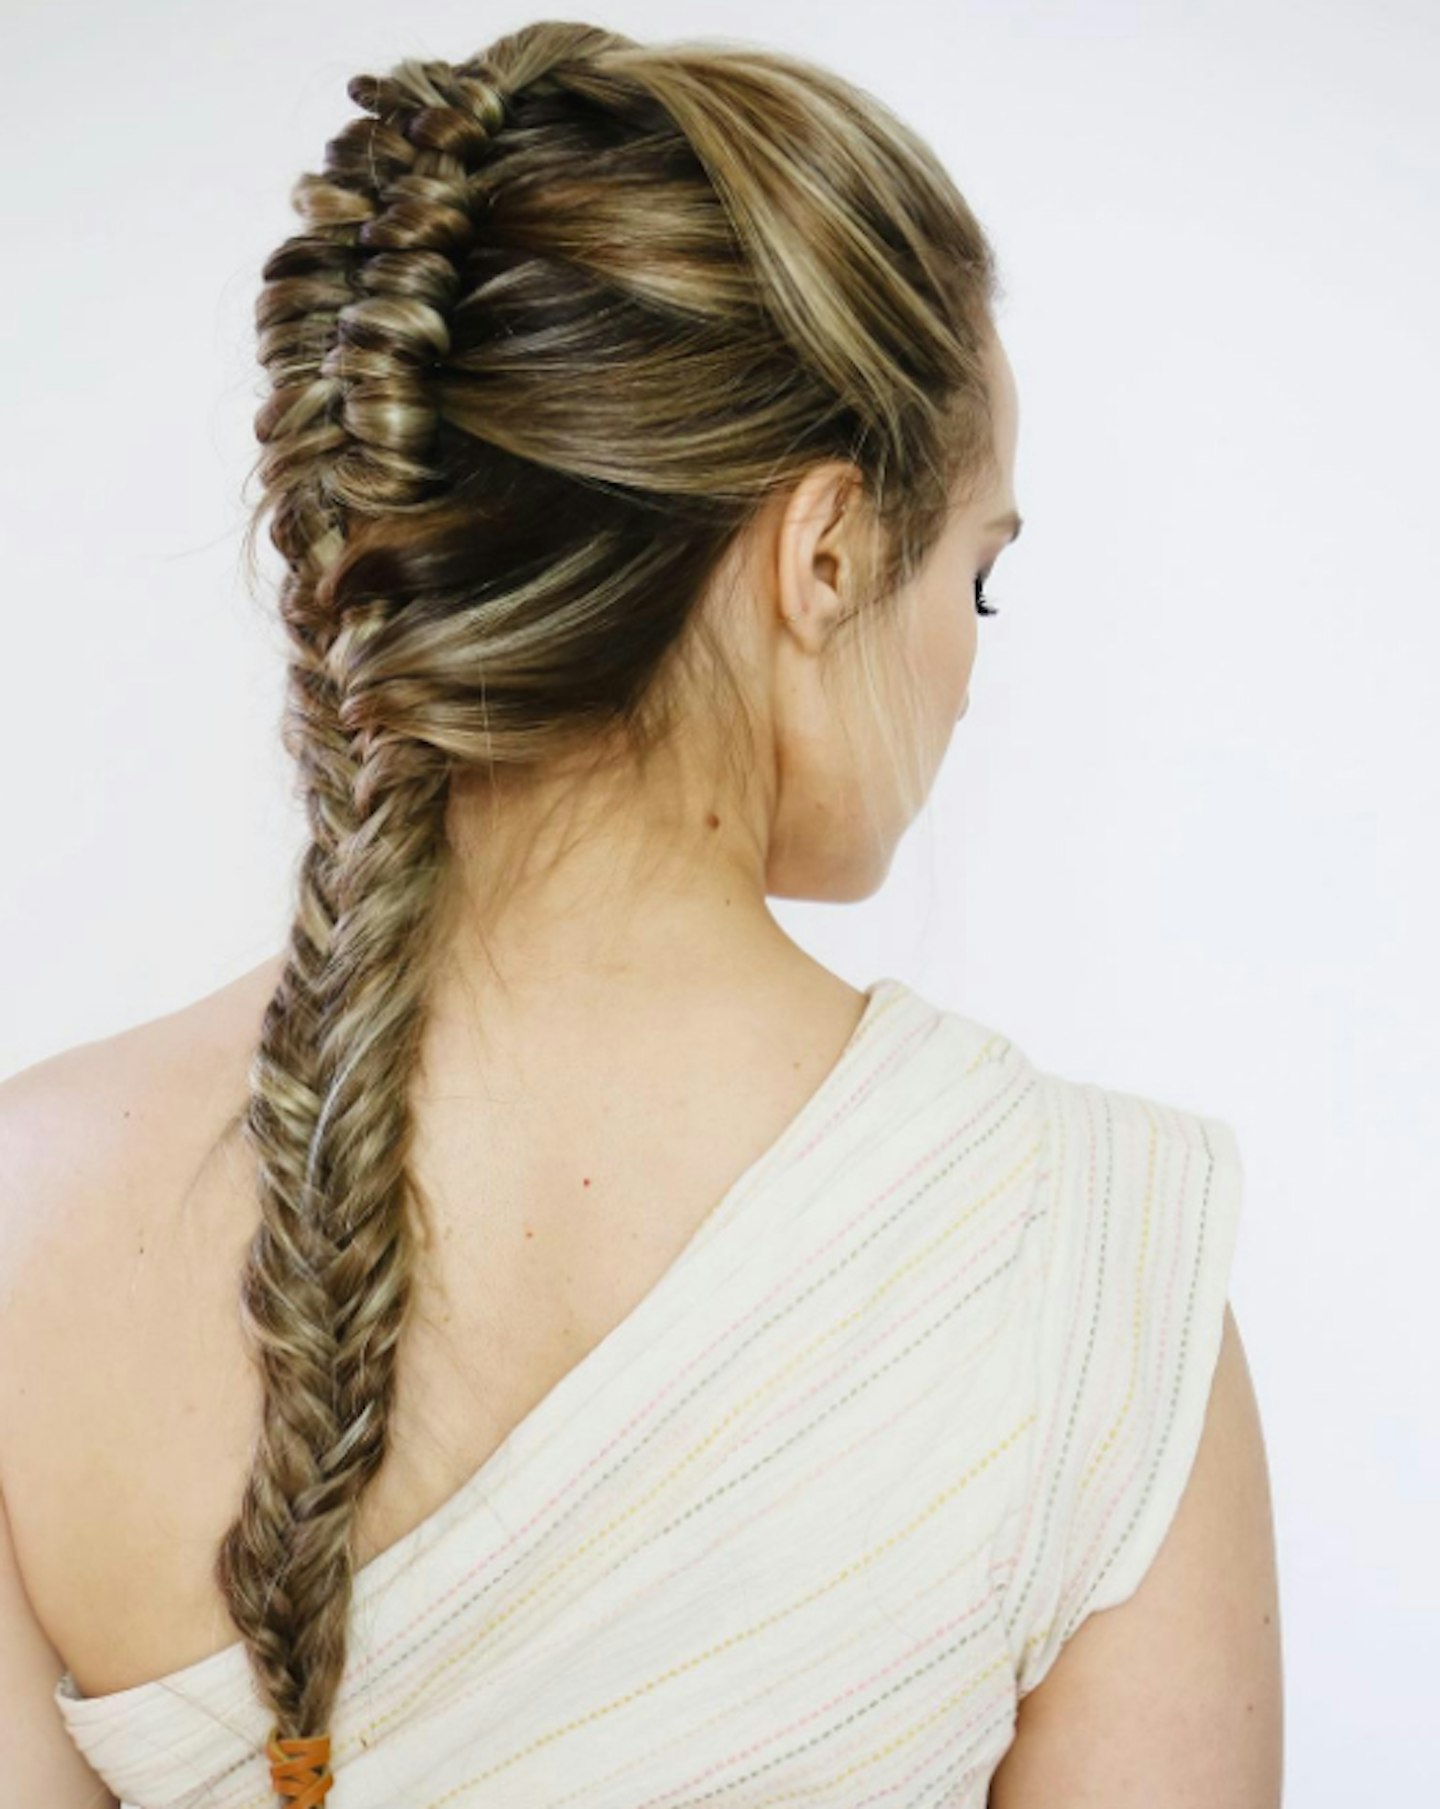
(215, 27), (608, 1805)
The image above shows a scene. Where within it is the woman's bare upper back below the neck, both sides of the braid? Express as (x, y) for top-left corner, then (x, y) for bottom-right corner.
(0, 957), (879, 1695)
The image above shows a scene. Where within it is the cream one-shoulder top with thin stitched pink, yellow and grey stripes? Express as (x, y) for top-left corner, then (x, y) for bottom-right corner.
(54, 979), (1241, 1809)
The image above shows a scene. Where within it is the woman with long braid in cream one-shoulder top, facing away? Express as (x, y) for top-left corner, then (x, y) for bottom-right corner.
(0, 22), (1279, 1809)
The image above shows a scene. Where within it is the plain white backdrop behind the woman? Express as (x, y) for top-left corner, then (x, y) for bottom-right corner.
(0, 0), (1440, 1809)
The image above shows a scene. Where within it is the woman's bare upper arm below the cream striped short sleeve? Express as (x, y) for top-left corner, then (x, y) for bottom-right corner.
(990, 1306), (1284, 1809)
